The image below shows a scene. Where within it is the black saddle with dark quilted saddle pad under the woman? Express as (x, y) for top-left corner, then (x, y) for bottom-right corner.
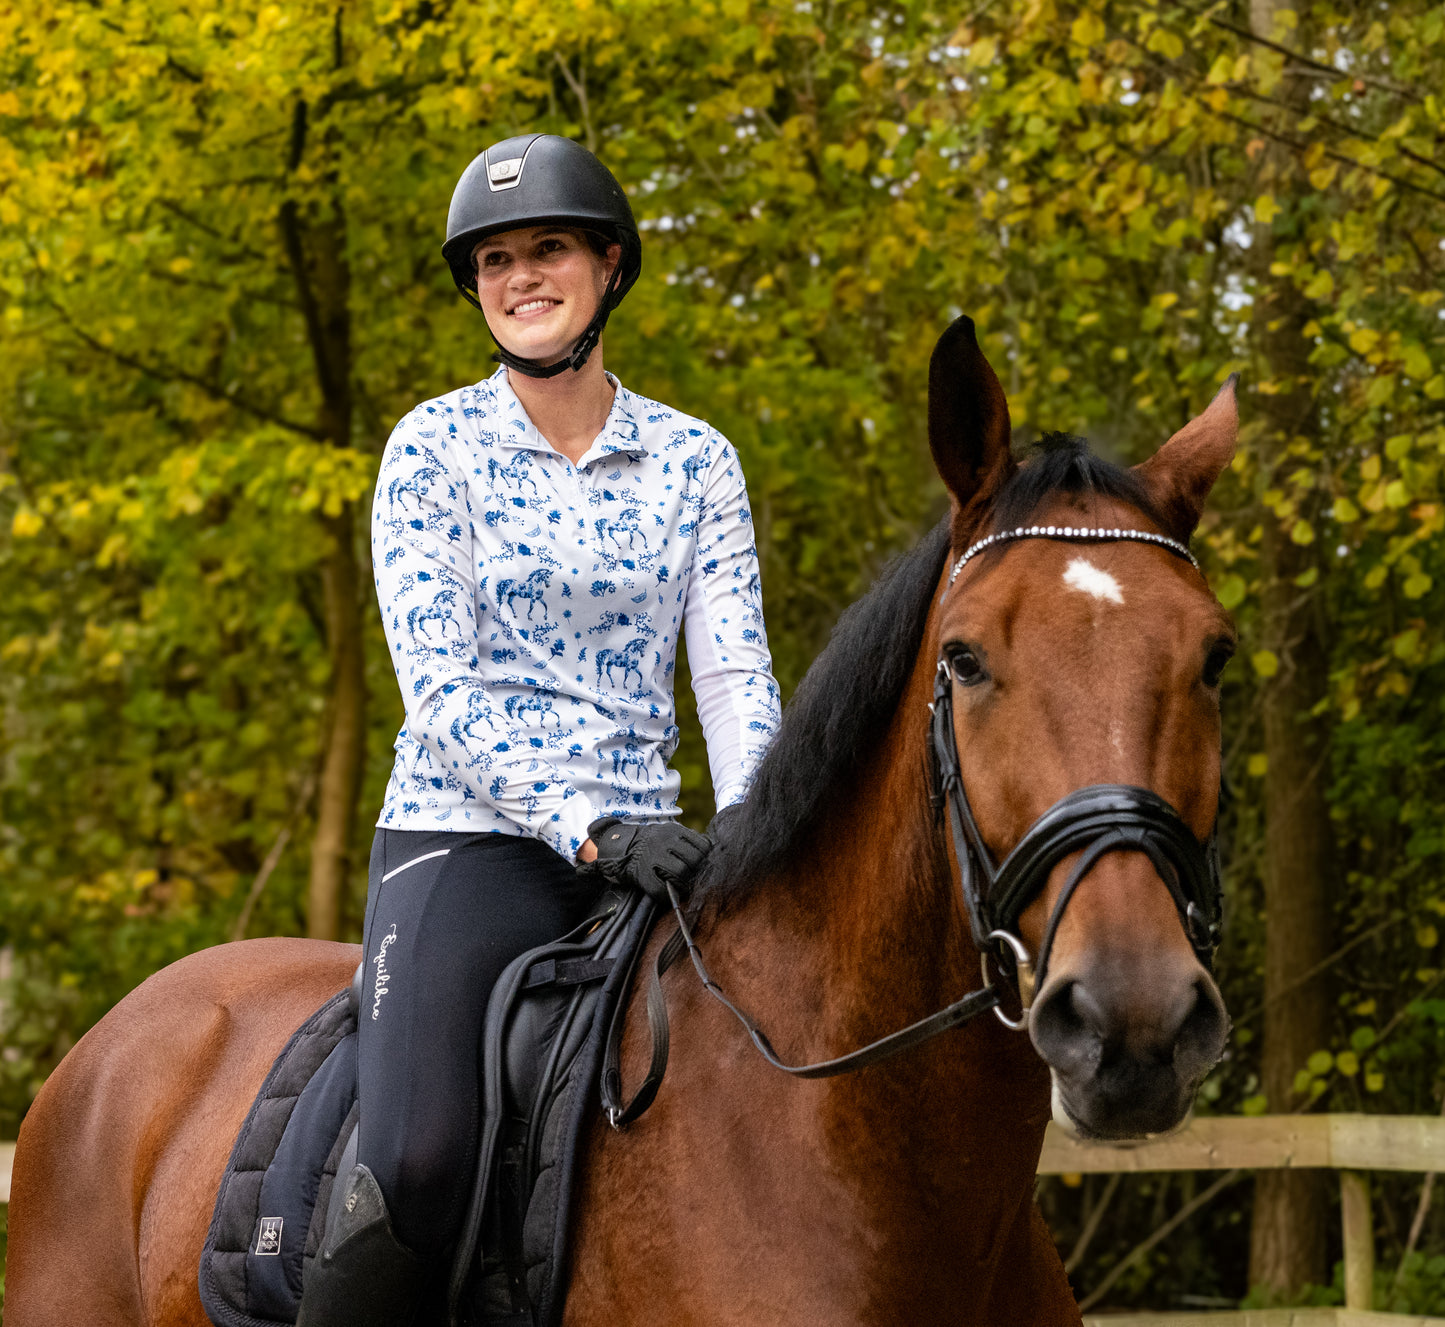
(199, 892), (655, 1327)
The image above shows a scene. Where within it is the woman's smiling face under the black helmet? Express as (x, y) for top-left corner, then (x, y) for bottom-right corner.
(473, 226), (621, 364)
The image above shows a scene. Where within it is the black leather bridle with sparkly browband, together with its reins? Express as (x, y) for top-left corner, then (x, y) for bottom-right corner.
(601, 525), (1224, 1130)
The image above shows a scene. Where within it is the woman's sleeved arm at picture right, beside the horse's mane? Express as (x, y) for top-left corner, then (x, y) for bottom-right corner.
(683, 434), (779, 809)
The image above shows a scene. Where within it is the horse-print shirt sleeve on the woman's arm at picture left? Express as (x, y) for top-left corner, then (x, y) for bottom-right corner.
(371, 412), (597, 860)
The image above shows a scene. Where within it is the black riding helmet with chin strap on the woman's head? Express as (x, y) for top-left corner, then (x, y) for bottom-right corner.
(442, 133), (642, 377)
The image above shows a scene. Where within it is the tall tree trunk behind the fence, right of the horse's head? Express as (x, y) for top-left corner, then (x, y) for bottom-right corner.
(1250, 0), (1335, 1295)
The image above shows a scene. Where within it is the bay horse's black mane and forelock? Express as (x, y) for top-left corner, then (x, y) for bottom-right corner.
(695, 434), (1163, 909)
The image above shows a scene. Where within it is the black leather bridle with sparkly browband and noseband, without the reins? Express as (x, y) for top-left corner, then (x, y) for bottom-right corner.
(929, 525), (1222, 1031)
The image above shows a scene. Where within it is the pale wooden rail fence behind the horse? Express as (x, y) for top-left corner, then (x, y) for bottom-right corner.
(0, 1115), (1445, 1327)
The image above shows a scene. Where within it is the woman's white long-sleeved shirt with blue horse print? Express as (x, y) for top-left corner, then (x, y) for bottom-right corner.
(371, 369), (779, 857)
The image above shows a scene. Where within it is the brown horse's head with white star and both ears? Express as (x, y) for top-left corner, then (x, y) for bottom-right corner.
(929, 318), (1237, 1139)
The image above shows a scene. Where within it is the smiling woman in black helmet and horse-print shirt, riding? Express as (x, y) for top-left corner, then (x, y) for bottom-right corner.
(299, 134), (777, 1327)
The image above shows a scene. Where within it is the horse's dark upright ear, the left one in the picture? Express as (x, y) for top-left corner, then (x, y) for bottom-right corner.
(928, 318), (1014, 529)
